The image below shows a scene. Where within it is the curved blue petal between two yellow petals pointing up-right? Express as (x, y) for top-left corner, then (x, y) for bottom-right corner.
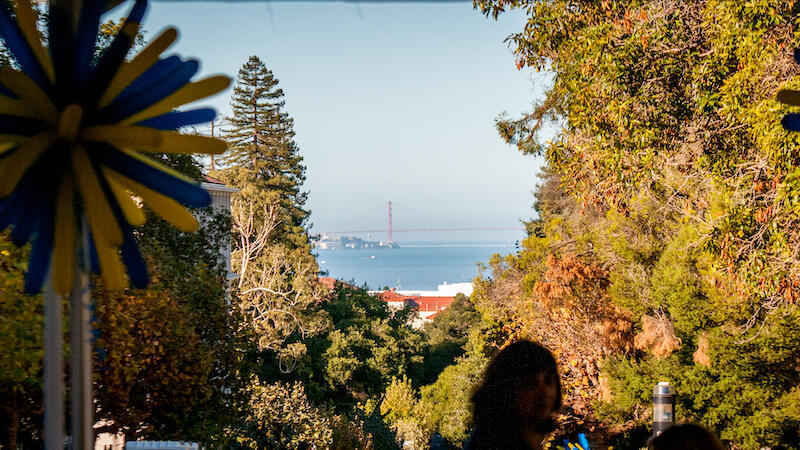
(96, 60), (199, 123)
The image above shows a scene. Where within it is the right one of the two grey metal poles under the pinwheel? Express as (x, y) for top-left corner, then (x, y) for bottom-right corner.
(70, 217), (94, 450)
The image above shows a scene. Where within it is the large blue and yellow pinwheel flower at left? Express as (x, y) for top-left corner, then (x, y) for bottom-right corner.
(0, 0), (230, 294)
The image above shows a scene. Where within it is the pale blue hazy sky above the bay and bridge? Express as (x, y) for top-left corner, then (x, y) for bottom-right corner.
(145, 2), (547, 242)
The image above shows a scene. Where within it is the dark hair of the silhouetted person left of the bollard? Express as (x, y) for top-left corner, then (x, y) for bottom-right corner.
(471, 341), (561, 448)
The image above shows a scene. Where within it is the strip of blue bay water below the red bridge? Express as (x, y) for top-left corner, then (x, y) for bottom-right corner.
(314, 241), (516, 291)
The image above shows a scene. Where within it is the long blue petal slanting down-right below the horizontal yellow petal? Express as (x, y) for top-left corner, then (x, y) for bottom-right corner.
(92, 144), (211, 208)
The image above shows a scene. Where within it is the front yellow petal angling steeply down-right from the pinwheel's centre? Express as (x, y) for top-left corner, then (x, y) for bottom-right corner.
(71, 147), (123, 246)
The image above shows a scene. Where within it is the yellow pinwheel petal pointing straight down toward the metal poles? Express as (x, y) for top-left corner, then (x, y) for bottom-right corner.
(50, 177), (77, 295)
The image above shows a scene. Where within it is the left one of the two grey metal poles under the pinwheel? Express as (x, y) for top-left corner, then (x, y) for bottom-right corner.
(43, 270), (64, 450)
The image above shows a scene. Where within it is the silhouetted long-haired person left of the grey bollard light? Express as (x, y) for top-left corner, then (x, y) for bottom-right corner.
(464, 341), (561, 450)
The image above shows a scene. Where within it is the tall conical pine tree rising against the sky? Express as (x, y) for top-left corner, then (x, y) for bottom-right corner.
(222, 56), (309, 247)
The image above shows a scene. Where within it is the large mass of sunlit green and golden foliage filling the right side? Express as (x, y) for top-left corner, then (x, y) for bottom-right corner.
(473, 0), (800, 448)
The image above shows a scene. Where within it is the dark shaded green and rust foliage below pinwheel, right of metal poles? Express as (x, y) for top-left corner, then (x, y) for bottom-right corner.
(93, 155), (241, 442)
